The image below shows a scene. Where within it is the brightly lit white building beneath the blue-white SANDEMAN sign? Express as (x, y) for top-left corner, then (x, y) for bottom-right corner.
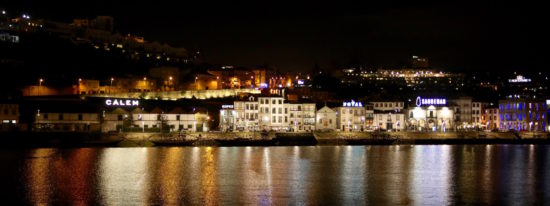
(406, 97), (454, 132)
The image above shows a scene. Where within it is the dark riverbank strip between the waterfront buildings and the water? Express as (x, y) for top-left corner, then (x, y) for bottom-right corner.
(0, 132), (550, 147)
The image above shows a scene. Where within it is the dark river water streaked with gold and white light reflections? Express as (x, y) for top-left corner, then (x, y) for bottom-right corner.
(0, 145), (550, 205)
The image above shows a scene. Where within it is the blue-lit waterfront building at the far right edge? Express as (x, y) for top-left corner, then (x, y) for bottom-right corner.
(498, 98), (547, 131)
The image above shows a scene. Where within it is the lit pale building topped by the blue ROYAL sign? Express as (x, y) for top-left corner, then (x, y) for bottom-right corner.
(335, 100), (367, 132)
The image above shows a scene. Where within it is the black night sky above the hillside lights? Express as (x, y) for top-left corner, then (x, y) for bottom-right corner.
(0, 0), (548, 71)
